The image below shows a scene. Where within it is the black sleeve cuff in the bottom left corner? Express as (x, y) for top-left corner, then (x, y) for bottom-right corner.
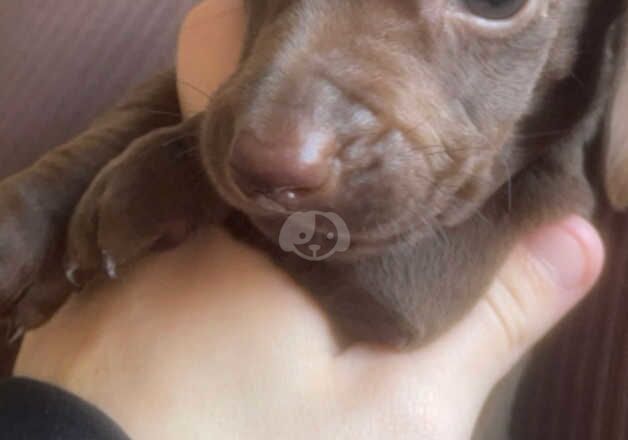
(0, 378), (129, 440)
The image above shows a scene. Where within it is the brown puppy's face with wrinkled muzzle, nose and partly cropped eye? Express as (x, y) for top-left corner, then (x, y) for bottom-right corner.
(203, 0), (588, 252)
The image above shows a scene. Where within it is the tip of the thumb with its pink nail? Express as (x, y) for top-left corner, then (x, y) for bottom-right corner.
(526, 217), (603, 290)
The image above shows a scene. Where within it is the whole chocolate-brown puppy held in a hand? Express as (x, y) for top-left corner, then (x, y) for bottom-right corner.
(0, 0), (628, 345)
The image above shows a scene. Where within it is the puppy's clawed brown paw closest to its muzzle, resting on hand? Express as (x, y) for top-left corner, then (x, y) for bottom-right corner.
(66, 128), (215, 286)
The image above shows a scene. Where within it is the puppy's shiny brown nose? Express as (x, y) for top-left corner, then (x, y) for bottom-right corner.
(230, 131), (336, 201)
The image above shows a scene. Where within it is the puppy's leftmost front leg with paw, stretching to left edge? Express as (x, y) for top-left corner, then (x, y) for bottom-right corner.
(0, 72), (180, 337)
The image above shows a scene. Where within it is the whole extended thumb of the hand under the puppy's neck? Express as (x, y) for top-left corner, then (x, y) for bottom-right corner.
(432, 217), (604, 386)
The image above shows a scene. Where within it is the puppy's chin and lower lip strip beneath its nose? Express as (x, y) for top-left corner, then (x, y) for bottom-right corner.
(208, 158), (499, 261)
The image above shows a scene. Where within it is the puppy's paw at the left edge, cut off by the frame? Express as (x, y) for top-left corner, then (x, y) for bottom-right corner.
(0, 175), (71, 338)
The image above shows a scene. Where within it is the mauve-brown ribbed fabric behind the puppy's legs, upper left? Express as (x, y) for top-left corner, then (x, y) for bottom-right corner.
(0, 0), (198, 374)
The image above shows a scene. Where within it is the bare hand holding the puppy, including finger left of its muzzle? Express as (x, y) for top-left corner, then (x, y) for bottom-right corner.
(16, 0), (604, 440)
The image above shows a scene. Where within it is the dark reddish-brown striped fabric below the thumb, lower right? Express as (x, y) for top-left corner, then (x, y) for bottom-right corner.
(513, 208), (628, 440)
